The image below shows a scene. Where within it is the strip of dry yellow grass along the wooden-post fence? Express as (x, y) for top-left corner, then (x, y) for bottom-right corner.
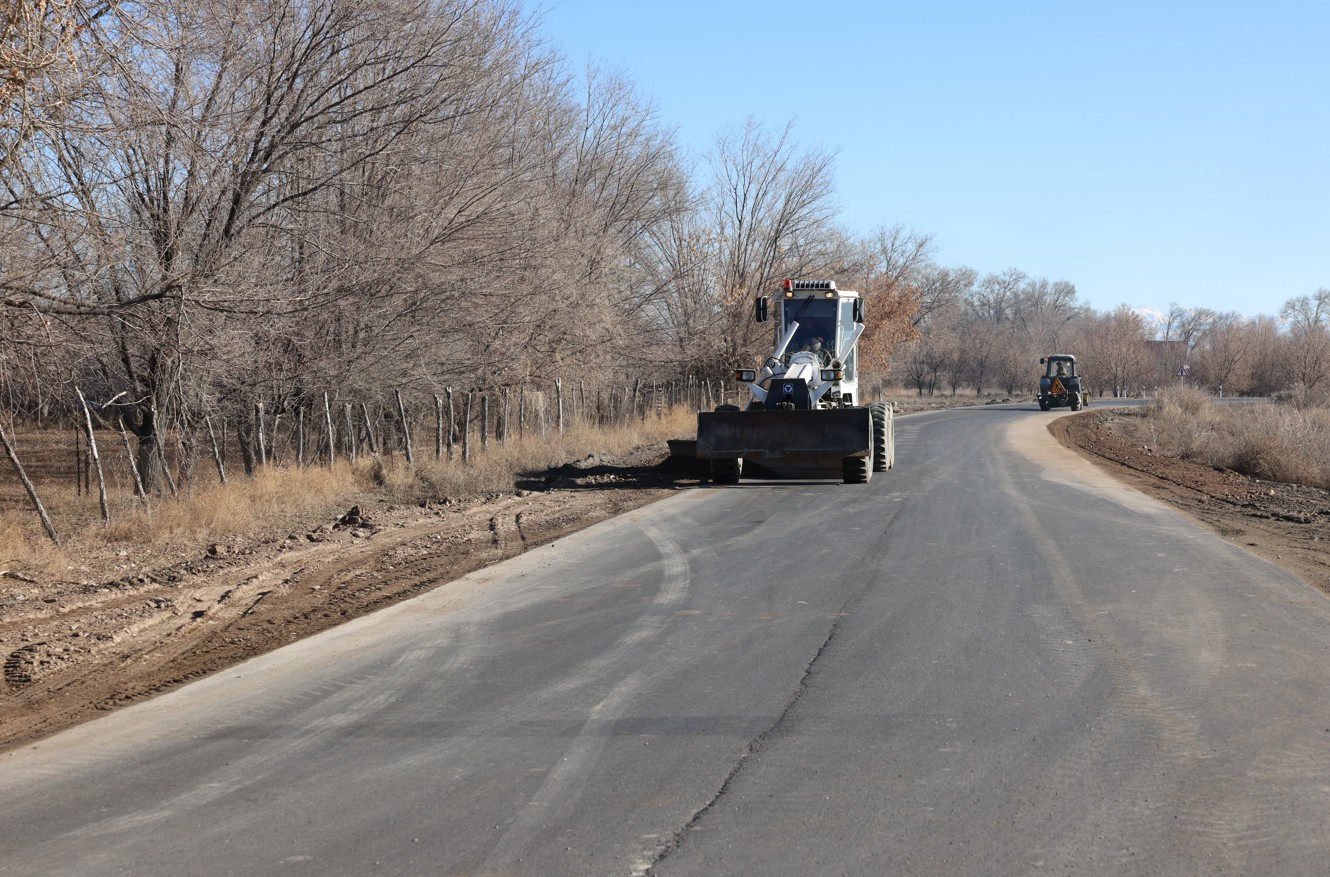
(0, 410), (696, 579)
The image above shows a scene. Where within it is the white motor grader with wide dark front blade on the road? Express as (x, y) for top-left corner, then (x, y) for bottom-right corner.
(696, 279), (895, 484)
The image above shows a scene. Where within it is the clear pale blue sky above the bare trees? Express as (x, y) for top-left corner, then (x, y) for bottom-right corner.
(528, 0), (1330, 322)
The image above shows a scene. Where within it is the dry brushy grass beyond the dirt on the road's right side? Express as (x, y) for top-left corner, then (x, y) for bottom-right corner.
(1149, 387), (1330, 488)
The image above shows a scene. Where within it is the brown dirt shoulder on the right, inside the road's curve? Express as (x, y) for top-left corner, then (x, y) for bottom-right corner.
(1049, 409), (1330, 594)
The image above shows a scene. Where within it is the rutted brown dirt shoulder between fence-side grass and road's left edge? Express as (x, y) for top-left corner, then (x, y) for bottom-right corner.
(0, 444), (697, 752)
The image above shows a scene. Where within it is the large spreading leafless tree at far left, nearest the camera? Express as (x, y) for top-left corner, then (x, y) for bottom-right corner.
(5, 0), (582, 484)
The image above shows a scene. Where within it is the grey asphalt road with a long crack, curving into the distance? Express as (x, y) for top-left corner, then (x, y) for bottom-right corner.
(0, 406), (1330, 877)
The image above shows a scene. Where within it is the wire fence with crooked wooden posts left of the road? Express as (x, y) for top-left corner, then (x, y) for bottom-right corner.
(0, 377), (734, 543)
